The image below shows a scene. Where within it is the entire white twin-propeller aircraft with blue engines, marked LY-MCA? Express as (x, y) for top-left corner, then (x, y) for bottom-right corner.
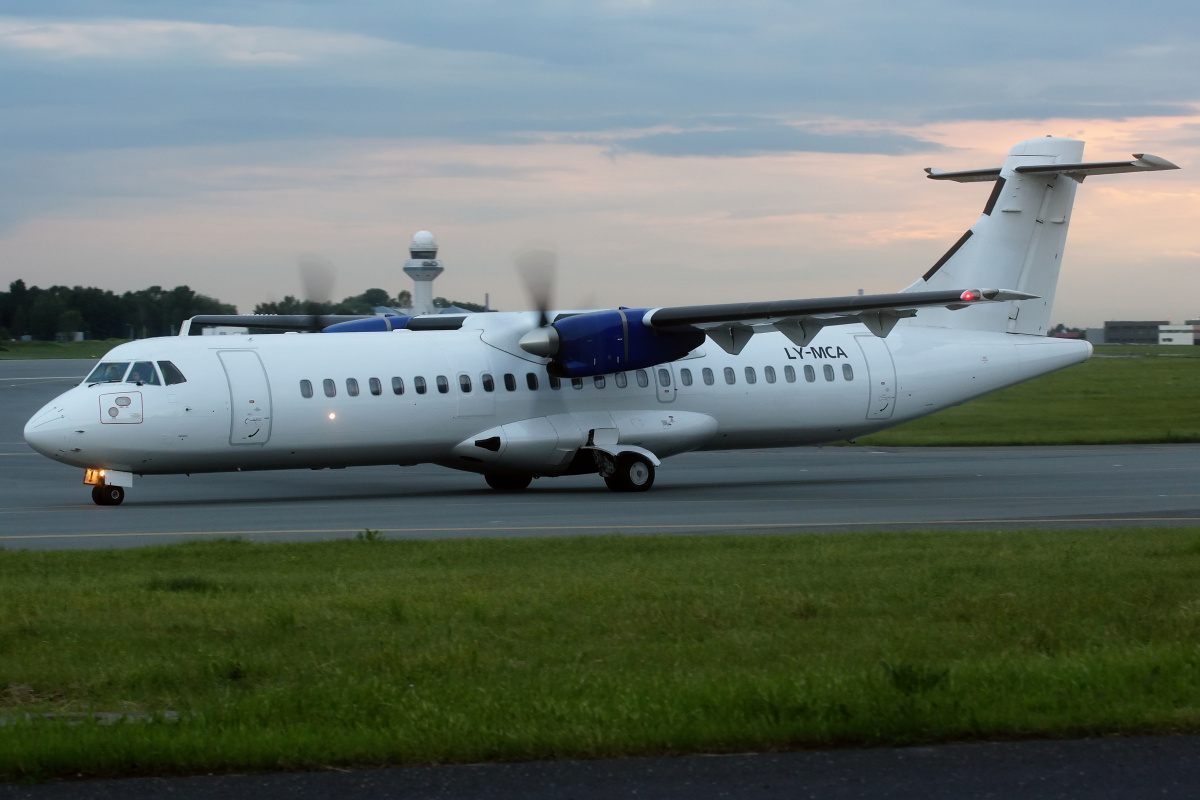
(25, 137), (1177, 505)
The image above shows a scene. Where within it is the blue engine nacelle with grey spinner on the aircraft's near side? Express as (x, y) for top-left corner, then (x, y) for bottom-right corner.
(521, 308), (704, 378)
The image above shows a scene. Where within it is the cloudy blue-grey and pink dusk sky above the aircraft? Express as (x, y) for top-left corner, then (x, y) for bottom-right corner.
(0, 0), (1200, 325)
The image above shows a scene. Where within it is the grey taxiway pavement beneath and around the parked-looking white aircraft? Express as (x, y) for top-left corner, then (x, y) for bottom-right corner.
(0, 361), (1200, 548)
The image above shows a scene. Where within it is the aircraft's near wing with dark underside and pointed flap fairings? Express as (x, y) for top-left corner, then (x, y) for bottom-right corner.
(642, 289), (1037, 355)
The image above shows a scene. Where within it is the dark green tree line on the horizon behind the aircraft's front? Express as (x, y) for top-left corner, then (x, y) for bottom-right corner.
(0, 279), (484, 341)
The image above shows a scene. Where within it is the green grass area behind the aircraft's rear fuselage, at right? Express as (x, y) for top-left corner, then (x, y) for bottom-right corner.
(858, 345), (1200, 447)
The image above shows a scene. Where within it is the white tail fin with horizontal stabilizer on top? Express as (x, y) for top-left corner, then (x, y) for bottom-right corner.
(904, 137), (1178, 336)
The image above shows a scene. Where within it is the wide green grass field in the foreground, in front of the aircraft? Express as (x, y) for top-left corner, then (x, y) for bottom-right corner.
(0, 528), (1200, 780)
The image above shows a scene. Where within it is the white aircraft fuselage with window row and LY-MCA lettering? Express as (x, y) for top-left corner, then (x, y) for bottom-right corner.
(25, 313), (1091, 475)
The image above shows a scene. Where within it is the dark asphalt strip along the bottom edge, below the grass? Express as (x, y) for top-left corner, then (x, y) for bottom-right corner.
(7, 736), (1200, 800)
